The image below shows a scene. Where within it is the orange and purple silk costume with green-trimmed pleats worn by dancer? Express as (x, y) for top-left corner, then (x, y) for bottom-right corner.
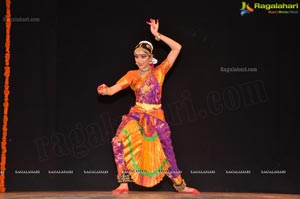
(112, 59), (186, 191)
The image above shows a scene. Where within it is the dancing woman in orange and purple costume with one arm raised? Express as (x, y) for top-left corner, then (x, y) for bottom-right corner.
(97, 19), (200, 194)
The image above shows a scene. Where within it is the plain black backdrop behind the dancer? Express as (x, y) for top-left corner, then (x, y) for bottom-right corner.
(0, 0), (300, 193)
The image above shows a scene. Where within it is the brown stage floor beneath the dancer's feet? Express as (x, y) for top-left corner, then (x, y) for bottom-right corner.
(0, 191), (300, 199)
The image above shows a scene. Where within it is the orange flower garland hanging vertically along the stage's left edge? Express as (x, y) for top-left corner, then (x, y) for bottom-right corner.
(0, 0), (11, 192)
